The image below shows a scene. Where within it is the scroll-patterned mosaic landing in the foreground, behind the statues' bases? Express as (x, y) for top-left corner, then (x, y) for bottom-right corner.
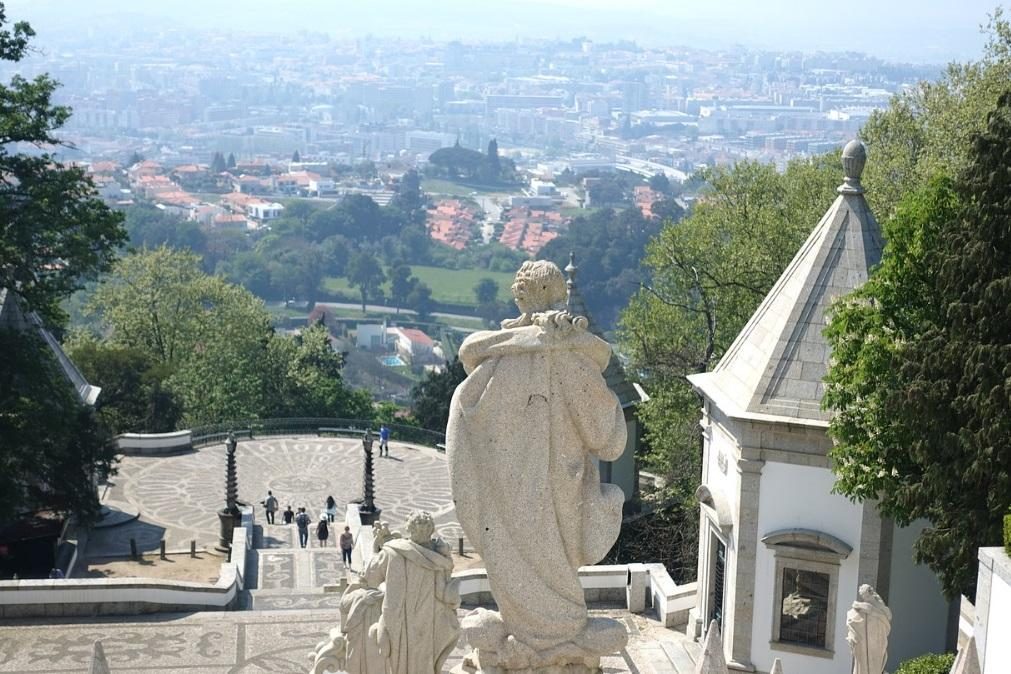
(0, 610), (693, 674)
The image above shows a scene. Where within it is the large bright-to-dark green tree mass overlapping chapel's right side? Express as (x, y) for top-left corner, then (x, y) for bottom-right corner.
(824, 92), (1011, 597)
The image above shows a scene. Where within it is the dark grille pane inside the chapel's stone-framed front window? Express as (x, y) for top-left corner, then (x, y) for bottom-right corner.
(779, 567), (830, 648)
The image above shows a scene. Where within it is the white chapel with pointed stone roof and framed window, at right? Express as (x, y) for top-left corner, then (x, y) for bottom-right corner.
(688, 141), (957, 674)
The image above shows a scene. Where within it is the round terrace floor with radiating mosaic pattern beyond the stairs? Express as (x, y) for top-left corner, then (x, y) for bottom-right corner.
(88, 437), (461, 557)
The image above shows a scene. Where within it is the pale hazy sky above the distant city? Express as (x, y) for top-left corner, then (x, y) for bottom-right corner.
(5, 0), (1000, 63)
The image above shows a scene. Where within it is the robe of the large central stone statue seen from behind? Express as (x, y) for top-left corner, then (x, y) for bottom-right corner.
(446, 325), (626, 650)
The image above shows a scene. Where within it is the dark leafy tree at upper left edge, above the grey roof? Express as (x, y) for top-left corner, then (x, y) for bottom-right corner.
(0, 5), (126, 319)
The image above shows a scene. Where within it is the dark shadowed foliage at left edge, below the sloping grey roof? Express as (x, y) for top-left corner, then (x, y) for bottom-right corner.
(0, 327), (115, 523)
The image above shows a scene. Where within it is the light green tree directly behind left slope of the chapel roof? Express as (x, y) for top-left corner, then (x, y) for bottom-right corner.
(618, 155), (841, 497)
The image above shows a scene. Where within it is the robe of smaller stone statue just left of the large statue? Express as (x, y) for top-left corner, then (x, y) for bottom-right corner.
(365, 539), (460, 674)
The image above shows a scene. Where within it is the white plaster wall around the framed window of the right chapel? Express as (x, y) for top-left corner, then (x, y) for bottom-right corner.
(751, 461), (862, 674)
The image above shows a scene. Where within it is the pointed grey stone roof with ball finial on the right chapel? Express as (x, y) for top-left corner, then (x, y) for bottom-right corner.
(688, 140), (884, 426)
